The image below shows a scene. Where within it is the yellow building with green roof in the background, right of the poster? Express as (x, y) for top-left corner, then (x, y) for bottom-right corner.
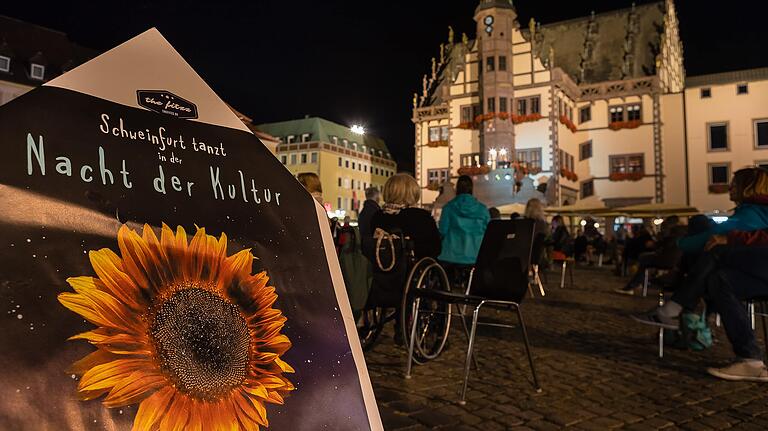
(256, 117), (397, 217)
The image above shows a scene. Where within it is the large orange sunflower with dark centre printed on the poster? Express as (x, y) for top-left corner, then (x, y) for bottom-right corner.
(59, 225), (294, 431)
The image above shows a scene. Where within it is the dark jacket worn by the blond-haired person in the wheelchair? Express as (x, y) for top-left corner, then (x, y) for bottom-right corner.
(371, 208), (440, 259)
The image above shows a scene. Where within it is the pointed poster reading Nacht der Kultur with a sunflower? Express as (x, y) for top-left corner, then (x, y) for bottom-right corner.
(0, 29), (381, 430)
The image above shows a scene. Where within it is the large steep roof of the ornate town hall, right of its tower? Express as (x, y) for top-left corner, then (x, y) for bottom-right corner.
(522, 2), (665, 84)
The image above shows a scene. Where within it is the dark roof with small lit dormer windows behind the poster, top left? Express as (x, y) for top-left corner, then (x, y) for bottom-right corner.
(0, 15), (97, 86)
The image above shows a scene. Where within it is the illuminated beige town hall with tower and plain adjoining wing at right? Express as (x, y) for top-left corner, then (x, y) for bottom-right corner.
(413, 0), (768, 215)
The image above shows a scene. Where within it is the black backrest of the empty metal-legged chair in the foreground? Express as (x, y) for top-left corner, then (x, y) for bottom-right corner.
(470, 219), (534, 302)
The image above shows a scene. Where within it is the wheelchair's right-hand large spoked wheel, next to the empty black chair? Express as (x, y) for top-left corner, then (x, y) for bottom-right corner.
(401, 257), (451, 364)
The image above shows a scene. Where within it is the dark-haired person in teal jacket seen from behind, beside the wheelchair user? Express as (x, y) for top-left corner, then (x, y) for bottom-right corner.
(438, 175), (491, 265)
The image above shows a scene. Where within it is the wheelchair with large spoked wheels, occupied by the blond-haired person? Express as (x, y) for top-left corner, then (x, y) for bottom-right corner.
(357, 233), (451, 363)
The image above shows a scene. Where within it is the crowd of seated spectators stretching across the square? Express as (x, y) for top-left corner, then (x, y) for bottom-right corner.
(299, 168), (768, 382)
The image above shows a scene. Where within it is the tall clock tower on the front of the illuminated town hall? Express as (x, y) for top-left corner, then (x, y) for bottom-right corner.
(475, 0), (518, 168)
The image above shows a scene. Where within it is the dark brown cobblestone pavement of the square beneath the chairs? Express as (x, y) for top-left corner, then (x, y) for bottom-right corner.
(366, 268), (768, 431)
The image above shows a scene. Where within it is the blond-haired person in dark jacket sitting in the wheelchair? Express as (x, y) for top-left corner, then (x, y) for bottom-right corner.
(368, 173), (440, 344)
